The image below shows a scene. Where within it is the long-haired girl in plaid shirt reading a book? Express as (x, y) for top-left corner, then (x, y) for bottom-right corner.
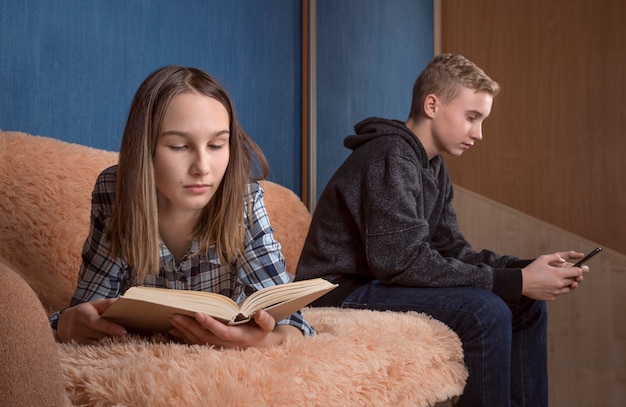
(50, 66), (315, 348)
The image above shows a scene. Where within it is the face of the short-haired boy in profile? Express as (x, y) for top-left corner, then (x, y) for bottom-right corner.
(429, 88), (493, 156)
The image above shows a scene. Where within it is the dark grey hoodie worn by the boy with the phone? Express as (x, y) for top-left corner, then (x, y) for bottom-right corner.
(296, 118), (529, 305)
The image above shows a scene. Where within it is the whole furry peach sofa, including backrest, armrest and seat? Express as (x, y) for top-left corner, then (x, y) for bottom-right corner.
(0, 131), (467, 407)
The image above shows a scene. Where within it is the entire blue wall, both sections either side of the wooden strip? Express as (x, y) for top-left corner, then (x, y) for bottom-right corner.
(0, 0), (433, 196)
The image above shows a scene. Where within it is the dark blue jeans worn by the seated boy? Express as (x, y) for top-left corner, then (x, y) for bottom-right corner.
(342, 280), (548, 407)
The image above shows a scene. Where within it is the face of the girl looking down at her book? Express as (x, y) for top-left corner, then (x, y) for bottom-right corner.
(153, 92), (230, 220)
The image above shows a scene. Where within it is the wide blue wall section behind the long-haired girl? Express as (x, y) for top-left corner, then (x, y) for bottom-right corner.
(0, 0), (301, 193)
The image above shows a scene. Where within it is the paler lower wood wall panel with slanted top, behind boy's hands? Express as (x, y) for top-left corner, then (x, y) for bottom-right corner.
(454, 187), (626, 407)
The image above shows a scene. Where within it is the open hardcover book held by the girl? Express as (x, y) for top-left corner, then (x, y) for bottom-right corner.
(102, 278), (337, 333)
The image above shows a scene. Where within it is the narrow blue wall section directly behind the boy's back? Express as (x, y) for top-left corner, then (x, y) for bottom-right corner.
(317, 0), (434, 198)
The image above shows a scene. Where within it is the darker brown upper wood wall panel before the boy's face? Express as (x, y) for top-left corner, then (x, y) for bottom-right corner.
(441, 0), (626, 253)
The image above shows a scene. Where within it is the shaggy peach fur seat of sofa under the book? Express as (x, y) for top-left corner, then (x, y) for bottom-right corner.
(59, 308), (467, 407)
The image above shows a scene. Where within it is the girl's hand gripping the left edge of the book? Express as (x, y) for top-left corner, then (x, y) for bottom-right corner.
(56, 298), (126, 344)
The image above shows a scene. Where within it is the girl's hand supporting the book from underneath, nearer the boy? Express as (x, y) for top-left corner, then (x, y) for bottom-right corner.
(170, 311), (301, 349)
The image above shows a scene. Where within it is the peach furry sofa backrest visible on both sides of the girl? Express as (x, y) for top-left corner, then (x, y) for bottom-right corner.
(0, 131), (311, 313)
